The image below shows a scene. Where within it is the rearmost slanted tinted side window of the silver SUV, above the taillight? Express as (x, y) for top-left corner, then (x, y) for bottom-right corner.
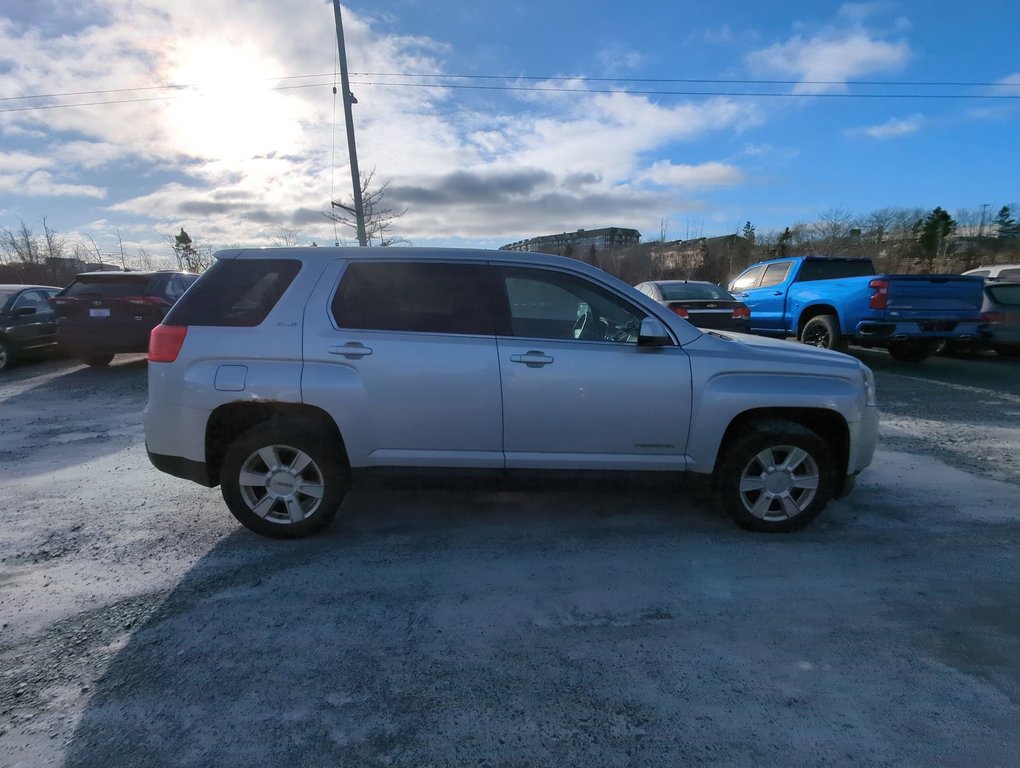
(163, 259), (301, 326)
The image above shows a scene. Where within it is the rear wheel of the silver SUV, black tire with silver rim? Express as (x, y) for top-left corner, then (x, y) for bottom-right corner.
(219, 421), (351, 539)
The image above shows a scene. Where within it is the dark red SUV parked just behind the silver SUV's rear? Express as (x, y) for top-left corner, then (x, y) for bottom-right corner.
(51, 270), (198, 365)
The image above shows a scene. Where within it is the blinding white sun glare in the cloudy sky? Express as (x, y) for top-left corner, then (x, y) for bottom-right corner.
(168, 41), (298, 160)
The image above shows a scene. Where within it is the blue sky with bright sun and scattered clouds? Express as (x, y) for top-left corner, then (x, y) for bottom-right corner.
(0, 0), (1020, 255)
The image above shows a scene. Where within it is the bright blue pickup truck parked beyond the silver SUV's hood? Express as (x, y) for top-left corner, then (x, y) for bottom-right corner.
(729, 256), (983, 361)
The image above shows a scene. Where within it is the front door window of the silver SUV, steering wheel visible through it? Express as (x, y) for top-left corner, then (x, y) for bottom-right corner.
(501, 268), (646, 344)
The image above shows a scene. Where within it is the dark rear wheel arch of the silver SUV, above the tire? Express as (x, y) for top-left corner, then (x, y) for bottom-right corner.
(205, 402), (348, 485)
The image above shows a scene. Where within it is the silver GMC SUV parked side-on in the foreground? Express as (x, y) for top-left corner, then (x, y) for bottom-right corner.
(144, 248), (878, 537)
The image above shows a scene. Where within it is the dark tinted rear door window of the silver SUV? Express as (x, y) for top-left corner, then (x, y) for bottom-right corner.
(333, 262), (496, 336)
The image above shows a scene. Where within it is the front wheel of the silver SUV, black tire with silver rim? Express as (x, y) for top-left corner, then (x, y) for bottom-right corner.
(715, 420), (836, 533)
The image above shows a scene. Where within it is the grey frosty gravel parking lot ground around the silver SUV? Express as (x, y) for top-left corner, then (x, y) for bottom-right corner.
(0, 350), (1020, 768)
